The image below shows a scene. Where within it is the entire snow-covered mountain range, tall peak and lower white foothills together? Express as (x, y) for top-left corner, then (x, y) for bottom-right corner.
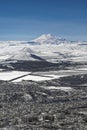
(0, 34), (87, 62)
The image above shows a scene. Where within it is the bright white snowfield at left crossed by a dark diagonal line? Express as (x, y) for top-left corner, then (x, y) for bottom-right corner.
(0, 71), (63, 82)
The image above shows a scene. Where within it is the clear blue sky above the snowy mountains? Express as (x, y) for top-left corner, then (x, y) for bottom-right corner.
(0, 0), (87, 41)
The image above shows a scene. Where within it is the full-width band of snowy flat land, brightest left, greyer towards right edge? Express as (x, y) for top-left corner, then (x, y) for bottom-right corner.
(0, 65), (87, 82)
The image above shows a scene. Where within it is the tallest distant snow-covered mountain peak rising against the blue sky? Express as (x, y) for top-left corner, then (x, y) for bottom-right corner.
(33, 34), (65, 44)
